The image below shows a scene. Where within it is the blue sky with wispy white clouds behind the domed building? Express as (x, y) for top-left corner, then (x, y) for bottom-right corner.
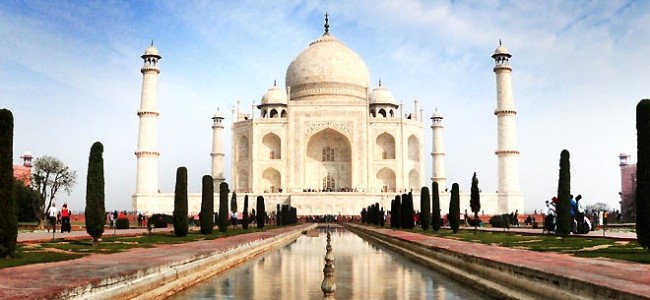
(0, 0), (650, 212)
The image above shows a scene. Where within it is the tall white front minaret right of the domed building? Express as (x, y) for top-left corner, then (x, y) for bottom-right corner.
(492, 40), (523, 213)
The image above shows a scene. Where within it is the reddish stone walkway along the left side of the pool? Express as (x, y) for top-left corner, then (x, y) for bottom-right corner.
(0, 225), (305, 299)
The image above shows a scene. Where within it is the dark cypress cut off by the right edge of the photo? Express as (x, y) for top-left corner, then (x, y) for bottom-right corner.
(634, 99), (650, 251)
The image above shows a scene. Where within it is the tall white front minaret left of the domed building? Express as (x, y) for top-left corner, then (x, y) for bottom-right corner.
(135, 42), (161, 195)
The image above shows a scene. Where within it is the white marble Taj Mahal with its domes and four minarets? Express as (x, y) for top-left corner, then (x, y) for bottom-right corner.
(132, 16), (524, 215)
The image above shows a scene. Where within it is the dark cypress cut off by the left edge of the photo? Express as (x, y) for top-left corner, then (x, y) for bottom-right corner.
(0, 109), (18, 258)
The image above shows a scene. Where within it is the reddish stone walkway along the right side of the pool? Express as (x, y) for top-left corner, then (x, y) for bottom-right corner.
(354, 226), (650, 299)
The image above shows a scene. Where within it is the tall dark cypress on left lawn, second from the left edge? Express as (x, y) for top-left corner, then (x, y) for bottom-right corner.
(85, 142), (106, 245)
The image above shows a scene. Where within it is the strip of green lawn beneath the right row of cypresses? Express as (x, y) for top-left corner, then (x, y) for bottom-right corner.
(408, 229), (650, 264)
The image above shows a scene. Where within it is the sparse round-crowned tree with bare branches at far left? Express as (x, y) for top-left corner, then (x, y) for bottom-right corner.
(32, 156), (77, 227)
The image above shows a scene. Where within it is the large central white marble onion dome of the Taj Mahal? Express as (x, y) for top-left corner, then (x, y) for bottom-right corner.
(285, 33), (369, 100)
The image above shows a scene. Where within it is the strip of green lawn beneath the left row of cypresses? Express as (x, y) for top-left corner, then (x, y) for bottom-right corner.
(0, 226), (275, 268)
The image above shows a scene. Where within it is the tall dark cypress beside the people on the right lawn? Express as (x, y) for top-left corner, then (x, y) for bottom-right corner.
(555, 149), (571, 237)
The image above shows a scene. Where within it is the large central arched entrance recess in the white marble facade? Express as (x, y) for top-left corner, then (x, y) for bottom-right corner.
(303, 128), (352, 192)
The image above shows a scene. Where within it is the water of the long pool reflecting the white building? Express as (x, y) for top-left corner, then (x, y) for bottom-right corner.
(172, 228), (488, 300)
